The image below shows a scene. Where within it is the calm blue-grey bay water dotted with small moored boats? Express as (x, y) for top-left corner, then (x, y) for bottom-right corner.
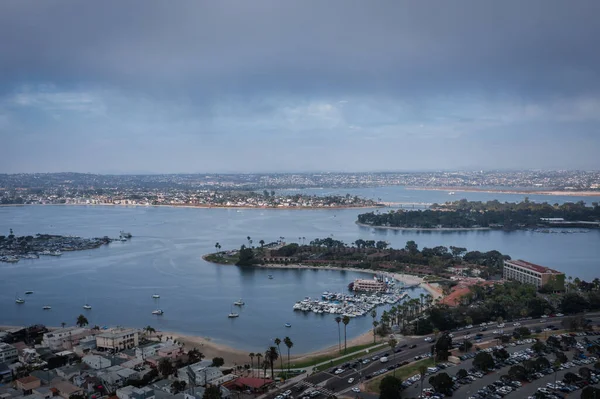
(0, 188), (600, 353)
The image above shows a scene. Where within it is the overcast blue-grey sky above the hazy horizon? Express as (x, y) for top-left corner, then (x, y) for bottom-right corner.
(0, 0), (600, 173)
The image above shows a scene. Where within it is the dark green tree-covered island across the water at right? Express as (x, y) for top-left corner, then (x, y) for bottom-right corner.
(357, 198), (600, 230)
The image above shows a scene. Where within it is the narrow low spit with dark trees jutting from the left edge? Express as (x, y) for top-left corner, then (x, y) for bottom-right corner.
(0, 233), (122, 263)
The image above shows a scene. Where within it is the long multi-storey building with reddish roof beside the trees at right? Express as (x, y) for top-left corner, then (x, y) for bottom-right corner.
(502, 260), (565, 291)
